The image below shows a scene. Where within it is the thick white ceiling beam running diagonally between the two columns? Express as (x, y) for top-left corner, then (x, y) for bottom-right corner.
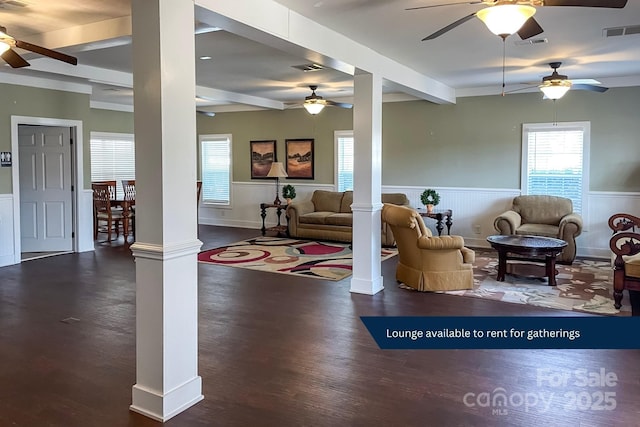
(195, 0), (455, 104)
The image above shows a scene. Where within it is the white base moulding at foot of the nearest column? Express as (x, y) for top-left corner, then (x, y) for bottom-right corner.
(129, 376), (204, 422)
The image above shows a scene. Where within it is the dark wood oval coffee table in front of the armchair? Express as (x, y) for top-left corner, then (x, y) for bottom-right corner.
(487, 235), (567, 286)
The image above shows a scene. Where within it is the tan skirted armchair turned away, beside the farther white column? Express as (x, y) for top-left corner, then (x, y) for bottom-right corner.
(382, 203), (475, 291)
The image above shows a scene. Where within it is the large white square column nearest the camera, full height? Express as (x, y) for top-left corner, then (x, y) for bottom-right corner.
(130, 0), (203, 421)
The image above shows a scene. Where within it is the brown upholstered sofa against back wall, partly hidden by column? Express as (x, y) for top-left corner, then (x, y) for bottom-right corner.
(287, 190), (410, 246)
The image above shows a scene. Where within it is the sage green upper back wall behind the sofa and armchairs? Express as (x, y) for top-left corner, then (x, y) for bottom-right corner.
(198, 87), (640, 192)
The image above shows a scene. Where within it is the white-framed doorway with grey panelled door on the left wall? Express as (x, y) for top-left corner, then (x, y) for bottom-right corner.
(11, 116), (82, 264)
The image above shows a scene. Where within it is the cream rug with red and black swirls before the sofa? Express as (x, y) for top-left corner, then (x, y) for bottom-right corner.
(198, 236), (398, 280)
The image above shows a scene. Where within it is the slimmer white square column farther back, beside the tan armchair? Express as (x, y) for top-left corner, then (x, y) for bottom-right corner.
(351, 73), (384, 295)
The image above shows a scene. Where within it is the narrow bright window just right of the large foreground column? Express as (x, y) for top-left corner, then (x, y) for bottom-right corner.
(200, 135), (231, 205)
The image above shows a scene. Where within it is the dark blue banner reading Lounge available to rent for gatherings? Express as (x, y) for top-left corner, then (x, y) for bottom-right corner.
(361, 316), (640, 350)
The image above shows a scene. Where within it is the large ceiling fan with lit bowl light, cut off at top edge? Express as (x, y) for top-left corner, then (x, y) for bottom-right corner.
(405, 0), (627, 41)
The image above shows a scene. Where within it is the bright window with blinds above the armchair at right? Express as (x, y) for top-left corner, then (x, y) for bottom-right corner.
(522, 122), (590, 213)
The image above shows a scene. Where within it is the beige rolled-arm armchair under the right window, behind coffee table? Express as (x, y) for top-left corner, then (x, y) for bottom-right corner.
(493, 195), (582, 264)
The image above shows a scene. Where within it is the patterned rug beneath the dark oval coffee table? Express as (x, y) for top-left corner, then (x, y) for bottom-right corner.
(446, 249), (631, 316)
